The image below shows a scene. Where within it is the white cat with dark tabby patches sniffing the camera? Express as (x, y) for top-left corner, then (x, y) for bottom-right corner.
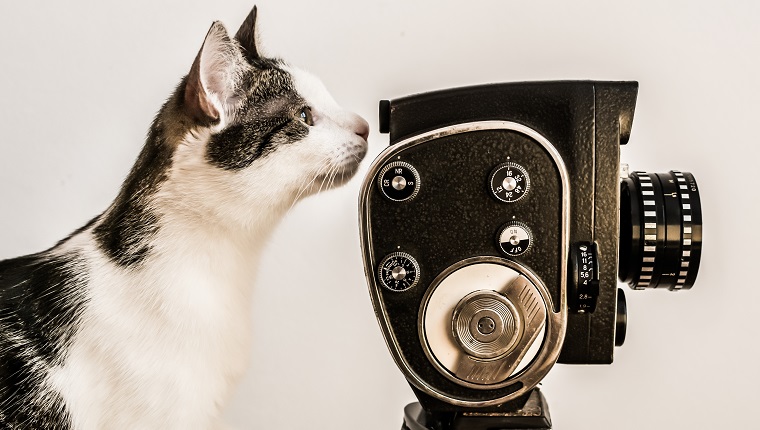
(0, 7), (369, 429)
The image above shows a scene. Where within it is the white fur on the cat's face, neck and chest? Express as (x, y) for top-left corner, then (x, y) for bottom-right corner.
(32, 32), (368, 430)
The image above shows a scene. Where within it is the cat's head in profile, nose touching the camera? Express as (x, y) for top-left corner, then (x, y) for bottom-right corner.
(164, 7), (369, 228)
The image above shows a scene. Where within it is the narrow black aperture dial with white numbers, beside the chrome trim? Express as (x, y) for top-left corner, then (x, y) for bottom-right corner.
(568, 242), (599, 312)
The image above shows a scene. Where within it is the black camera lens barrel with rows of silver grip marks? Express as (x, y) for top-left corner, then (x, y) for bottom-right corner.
(618, 170), (702, 291)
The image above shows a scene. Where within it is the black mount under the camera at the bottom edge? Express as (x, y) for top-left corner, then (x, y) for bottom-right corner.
(401, 388), (552, 430)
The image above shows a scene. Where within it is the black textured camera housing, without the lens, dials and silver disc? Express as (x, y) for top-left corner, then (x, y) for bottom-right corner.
(360, 81), (638, 410)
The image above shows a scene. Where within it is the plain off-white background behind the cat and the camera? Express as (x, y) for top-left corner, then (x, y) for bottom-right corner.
(0, 0), (760, 430)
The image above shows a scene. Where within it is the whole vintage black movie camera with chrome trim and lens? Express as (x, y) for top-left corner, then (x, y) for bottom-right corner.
(360, 81), (701, 411)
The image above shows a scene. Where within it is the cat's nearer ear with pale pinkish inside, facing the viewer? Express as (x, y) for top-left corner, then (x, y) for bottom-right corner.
(184, 21), (245, 124)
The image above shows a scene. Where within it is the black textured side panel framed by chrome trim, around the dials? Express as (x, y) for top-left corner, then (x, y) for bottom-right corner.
(360, 121), (569, 406)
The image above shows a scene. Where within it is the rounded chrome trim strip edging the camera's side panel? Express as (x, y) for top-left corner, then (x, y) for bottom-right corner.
(359, 121), (570, 407)
